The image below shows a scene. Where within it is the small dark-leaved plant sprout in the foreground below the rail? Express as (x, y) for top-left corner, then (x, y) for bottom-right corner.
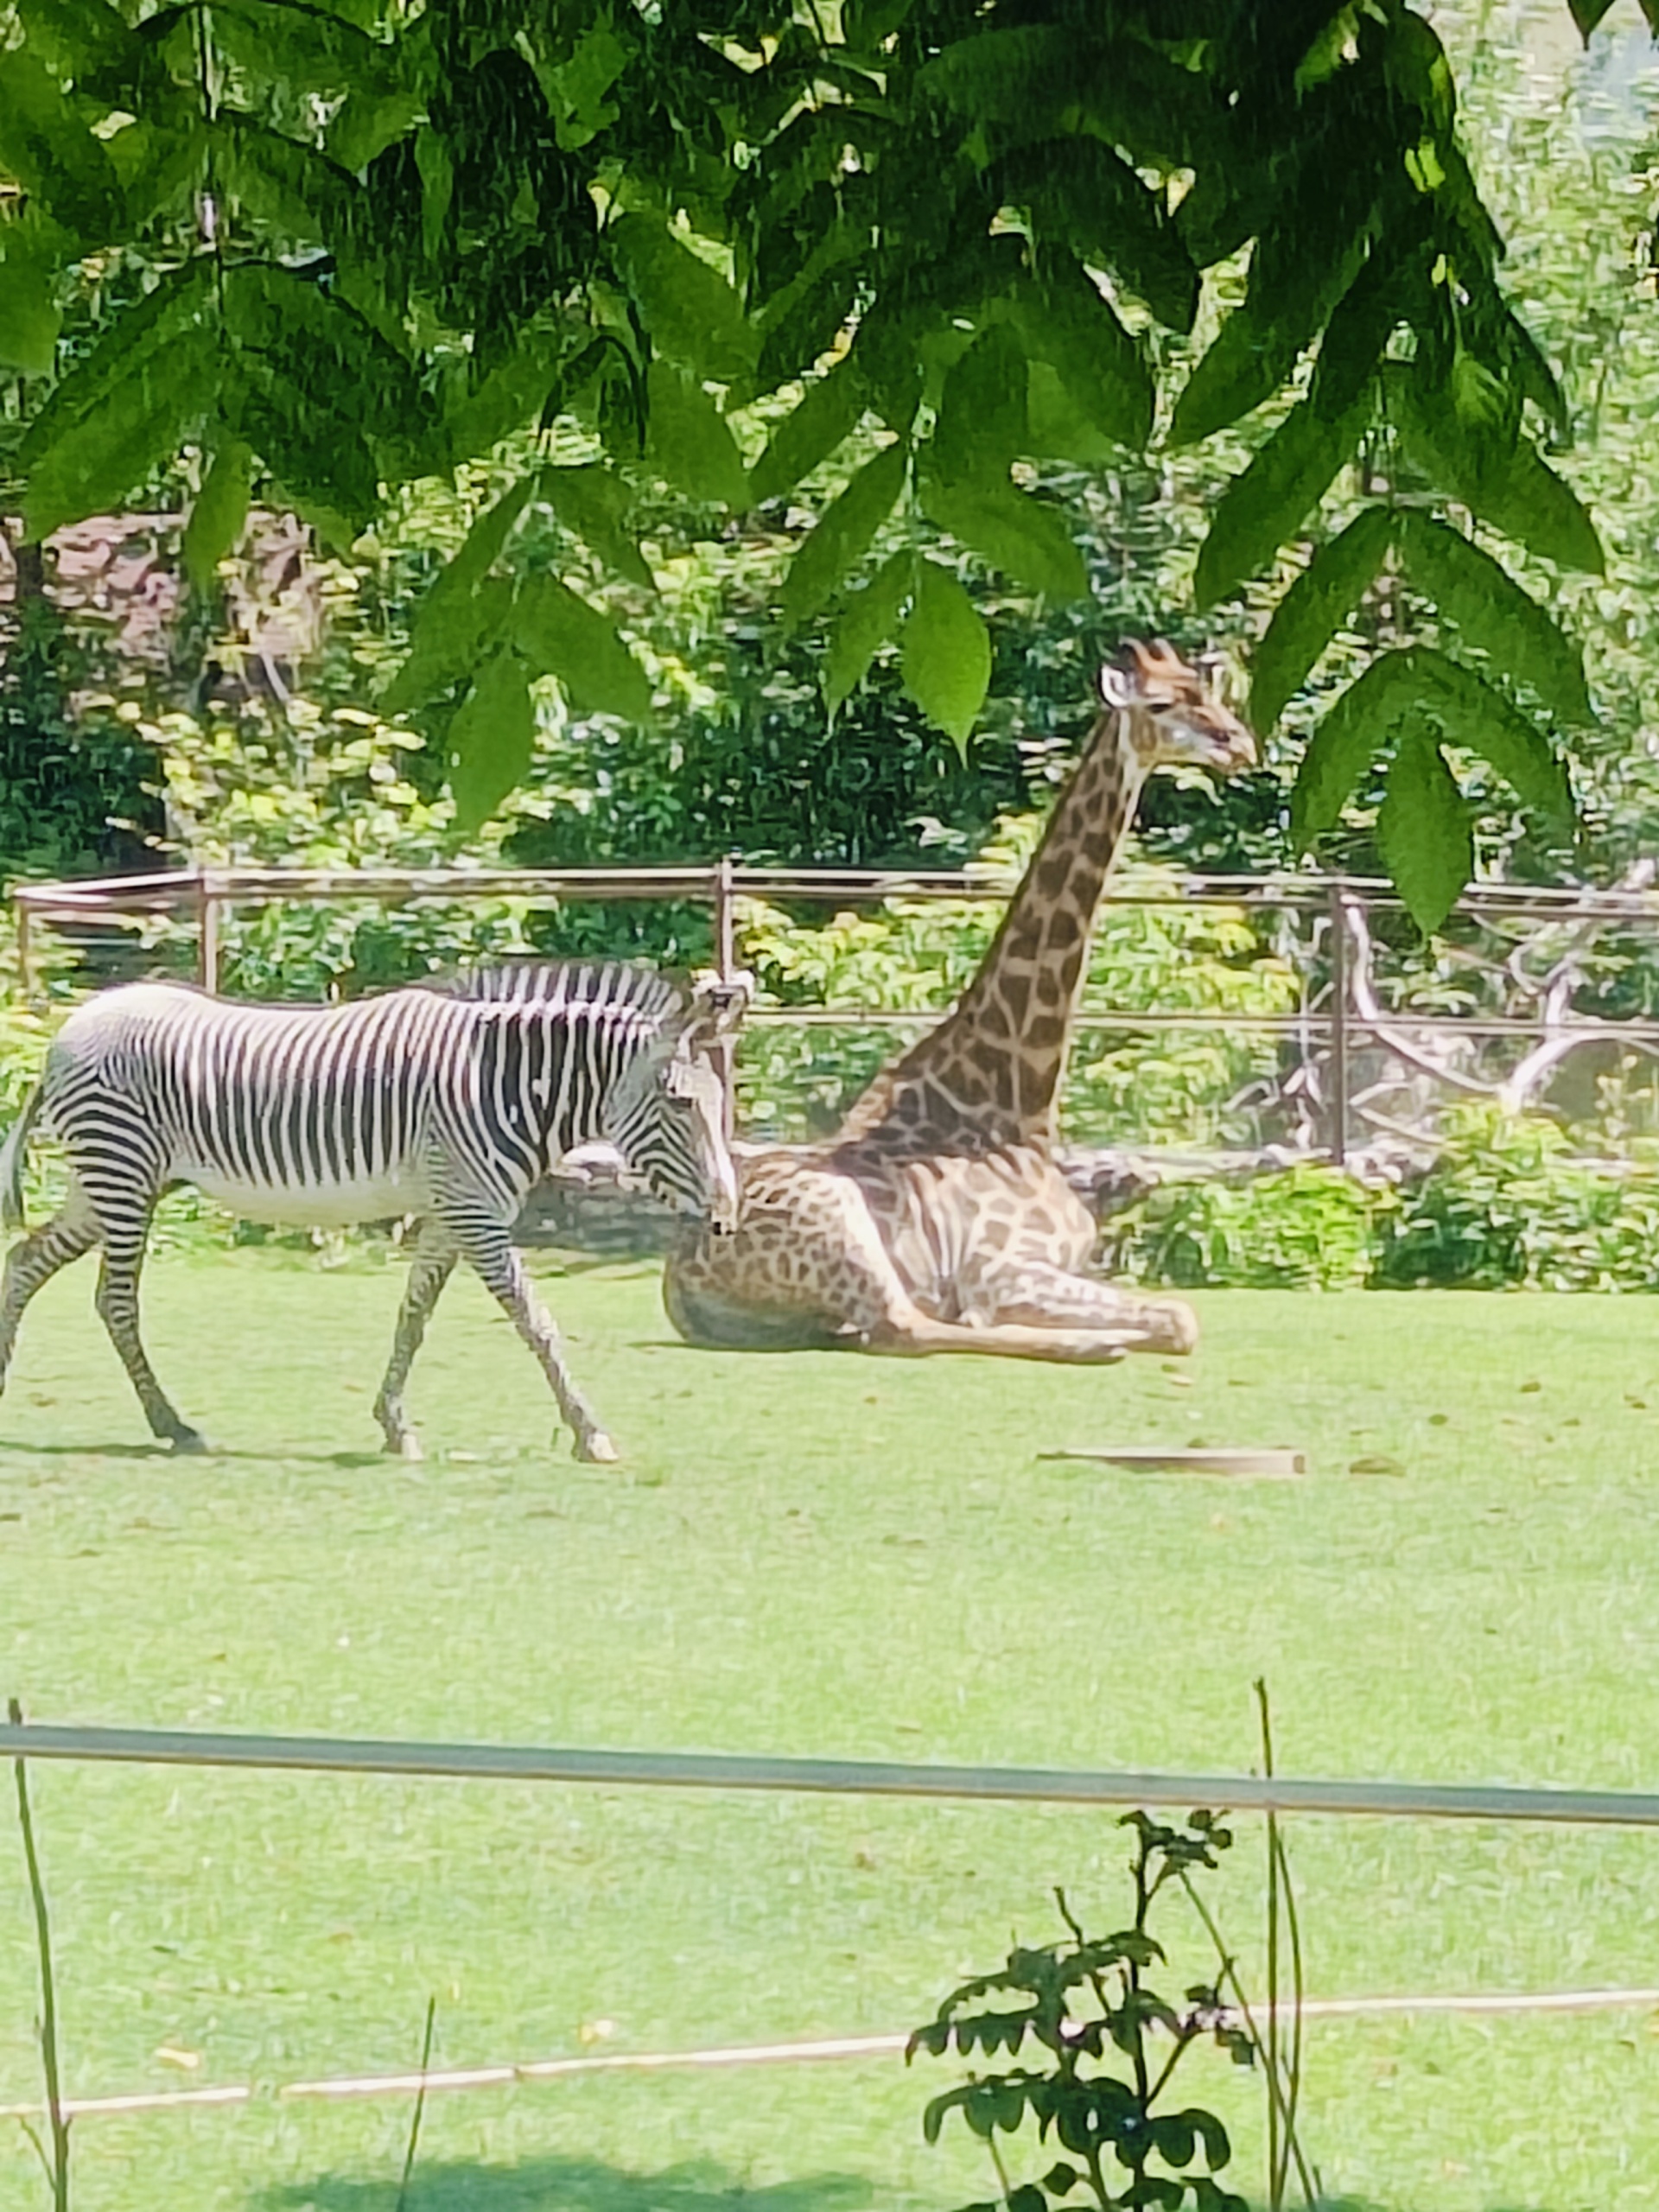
(905, 1812), (1256, 2212)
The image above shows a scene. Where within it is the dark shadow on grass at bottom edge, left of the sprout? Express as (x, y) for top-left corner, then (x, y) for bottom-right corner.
(250, 2159), (874, 2212)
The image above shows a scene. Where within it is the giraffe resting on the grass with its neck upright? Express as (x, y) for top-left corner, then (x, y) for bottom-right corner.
(664, 639), (1256, 1365)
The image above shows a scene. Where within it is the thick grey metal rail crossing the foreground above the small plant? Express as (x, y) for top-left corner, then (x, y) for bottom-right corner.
(0, 1723), (1659, 1827)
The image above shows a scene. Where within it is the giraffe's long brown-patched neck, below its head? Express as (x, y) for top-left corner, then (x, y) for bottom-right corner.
(838, 708), (1146, 1146)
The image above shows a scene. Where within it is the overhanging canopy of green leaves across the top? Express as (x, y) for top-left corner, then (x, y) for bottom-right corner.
(0, 0), (1659, 927)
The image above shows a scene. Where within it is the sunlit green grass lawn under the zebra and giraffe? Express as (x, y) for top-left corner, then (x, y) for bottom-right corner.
(0, 1255), (1659, 2212)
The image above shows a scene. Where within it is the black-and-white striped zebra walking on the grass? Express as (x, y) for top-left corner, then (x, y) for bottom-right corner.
(0, 963), (746, 1460)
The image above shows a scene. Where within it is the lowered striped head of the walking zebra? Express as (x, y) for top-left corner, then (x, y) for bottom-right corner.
(601, 978), (747, 1236)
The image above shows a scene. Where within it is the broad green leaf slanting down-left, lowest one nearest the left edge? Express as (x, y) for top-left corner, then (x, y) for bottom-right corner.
(22, 325), (219, 540)
